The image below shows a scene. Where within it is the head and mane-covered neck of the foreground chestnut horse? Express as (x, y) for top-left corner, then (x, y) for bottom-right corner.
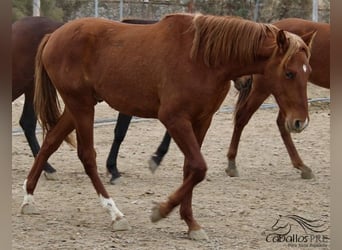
(190, 15), (313, 132)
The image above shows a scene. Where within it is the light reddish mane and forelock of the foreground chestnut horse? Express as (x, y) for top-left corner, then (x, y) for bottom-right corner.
(190, 14), (310, 67)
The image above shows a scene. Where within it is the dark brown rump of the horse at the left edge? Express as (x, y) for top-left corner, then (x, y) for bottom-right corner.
(12, 17), (63, 101)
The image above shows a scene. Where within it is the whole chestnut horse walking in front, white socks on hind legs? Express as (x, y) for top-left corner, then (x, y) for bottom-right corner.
(21, 14), (314, 240)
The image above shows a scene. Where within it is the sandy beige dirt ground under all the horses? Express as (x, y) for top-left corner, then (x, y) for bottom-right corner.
(12, 85), (331, 250)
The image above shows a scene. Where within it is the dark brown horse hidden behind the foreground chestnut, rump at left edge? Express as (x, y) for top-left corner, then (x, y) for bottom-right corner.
(12, 16), (156, 180)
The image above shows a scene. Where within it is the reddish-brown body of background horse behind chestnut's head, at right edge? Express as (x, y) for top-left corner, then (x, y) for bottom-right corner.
(274, 18), (330, 88)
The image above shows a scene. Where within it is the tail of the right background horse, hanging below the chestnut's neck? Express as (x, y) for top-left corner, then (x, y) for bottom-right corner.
(234, 75), (253, 122)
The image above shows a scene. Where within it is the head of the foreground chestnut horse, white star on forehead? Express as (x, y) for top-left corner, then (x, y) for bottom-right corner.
(262, 27), (315, 132)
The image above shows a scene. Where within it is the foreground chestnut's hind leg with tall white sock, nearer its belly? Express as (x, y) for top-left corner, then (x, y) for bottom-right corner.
(69, 103), (129, 231)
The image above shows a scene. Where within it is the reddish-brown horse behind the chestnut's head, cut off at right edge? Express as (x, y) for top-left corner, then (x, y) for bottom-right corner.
(226, 18), (330, 179)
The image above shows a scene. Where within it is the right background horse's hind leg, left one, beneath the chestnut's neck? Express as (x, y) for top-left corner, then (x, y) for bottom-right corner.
(225, 85), (270, 177)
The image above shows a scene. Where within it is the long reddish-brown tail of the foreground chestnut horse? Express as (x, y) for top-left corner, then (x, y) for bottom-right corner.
(33, 34), (75, 146)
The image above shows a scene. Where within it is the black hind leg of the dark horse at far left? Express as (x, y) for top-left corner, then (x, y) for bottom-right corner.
(19, 94), (58, 180)
